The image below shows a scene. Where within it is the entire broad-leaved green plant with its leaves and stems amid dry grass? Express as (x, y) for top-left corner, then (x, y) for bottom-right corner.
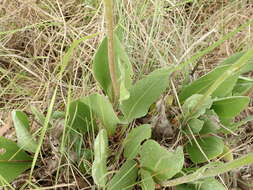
(0, 0), (253, 190)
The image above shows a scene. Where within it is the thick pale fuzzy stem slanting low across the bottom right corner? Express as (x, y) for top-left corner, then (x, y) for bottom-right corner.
(161, 153), (253, 187)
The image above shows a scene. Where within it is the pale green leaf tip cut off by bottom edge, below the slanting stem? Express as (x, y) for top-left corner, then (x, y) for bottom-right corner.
(199, 178), (227, 190)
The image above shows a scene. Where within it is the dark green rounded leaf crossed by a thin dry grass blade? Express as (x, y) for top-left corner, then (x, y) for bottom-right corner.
(186, 136), (224, 164)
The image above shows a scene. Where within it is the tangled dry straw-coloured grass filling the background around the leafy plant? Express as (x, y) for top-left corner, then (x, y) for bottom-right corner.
(0, 0), (253, 189)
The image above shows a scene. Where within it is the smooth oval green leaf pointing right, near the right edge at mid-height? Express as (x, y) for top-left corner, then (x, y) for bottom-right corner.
(212, 96), (249, 118)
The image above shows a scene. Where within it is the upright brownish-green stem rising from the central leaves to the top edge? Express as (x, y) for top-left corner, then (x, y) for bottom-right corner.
(104, 0), (119, 100)
